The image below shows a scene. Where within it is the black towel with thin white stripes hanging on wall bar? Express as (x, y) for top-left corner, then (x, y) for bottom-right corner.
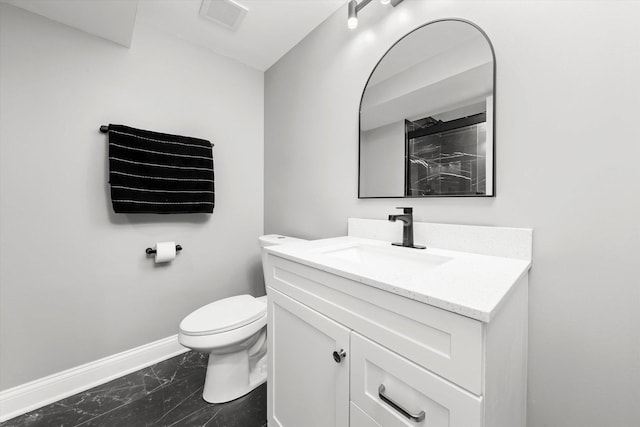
(108, 125), (214, 214)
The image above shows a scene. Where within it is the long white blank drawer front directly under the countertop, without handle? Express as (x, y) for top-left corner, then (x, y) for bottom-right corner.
(266, 255), (483, 395)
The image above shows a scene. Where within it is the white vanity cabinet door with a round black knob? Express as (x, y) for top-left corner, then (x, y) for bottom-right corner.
(267, 289), (350, 427)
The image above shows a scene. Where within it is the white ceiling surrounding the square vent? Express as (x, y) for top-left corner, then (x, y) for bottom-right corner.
(0, 0), (347, 71)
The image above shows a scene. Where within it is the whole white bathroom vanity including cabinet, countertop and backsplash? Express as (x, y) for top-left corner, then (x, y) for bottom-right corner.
(265, 219), (532, 427)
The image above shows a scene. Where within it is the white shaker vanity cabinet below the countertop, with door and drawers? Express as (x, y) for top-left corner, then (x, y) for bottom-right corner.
(265, 252), (527, 427)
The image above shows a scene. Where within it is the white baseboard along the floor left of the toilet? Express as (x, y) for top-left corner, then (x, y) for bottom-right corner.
(0, 335), (189, 422)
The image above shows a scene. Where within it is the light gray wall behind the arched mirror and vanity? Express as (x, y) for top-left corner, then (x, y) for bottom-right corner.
(265, 0), (640, 427)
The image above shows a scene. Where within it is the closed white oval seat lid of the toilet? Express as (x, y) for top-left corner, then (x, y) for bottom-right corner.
(180, 295), (267, 335)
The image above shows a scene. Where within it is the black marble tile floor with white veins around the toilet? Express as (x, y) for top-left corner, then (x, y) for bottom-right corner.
(0, 351), (267, 427)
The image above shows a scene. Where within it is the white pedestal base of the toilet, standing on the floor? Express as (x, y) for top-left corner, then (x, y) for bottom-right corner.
(202, 351), (267, 403)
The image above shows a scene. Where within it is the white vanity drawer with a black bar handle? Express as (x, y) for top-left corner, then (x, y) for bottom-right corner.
(350, 332), (482, 427)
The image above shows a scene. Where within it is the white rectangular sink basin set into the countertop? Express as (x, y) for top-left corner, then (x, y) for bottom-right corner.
(322, 244), (453, 274)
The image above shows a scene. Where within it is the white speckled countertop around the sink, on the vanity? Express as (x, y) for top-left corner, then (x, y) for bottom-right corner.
(266, 236), (531, 322)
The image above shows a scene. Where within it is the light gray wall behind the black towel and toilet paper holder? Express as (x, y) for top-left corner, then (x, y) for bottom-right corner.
(0, 4), (264, 389)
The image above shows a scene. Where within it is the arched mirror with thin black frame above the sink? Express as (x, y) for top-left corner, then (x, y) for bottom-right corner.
(358, 19), (495, 198)
